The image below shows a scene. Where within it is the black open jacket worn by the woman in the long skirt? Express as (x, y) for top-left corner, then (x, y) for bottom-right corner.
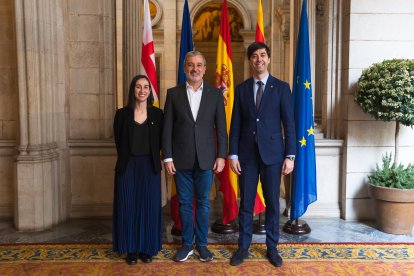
(113, 106), (163, 173)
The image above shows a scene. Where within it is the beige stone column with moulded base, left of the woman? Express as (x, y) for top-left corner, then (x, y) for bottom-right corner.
(14, 0), (70, 231)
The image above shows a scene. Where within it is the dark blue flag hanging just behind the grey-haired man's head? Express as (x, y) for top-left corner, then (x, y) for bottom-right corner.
(177, 0), (194, 84)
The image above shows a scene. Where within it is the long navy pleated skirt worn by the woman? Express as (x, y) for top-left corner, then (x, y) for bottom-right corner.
(112, 155), (162, 256)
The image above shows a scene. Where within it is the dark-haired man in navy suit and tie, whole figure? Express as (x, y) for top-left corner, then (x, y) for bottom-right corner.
(229, 42), (296, 266)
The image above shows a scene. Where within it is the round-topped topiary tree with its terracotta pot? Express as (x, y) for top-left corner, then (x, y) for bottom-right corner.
(355, 59), (414, 234)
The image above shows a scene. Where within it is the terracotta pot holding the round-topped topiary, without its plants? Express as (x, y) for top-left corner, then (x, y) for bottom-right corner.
(368, 183), (414, 234)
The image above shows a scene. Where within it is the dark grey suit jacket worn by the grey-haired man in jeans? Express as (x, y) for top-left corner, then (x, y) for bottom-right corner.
(162, 83), (227, 170)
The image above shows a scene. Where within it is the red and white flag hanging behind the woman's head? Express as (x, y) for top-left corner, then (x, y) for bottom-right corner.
(140, 0), (160, 107)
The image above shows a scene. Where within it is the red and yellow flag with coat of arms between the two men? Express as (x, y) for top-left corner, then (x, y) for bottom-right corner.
(216, 0), (239, 224)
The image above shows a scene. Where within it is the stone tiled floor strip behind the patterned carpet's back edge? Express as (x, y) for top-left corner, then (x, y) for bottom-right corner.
(0, 200), (414, 243)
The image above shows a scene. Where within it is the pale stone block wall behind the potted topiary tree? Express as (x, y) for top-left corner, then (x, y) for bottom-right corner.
(342, 0), (414, 219)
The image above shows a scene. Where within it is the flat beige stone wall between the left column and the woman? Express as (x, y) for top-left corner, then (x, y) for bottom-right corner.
(67, 0), (116, 217)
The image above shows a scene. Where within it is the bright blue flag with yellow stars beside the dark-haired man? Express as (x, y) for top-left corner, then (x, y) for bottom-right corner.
(290, 0), (317, 221)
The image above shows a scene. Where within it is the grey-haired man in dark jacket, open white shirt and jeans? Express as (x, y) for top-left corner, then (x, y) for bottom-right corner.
(162, 51), (227, 262)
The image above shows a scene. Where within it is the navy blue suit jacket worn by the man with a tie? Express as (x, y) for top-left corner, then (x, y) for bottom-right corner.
(229, 75), (296, 165)
